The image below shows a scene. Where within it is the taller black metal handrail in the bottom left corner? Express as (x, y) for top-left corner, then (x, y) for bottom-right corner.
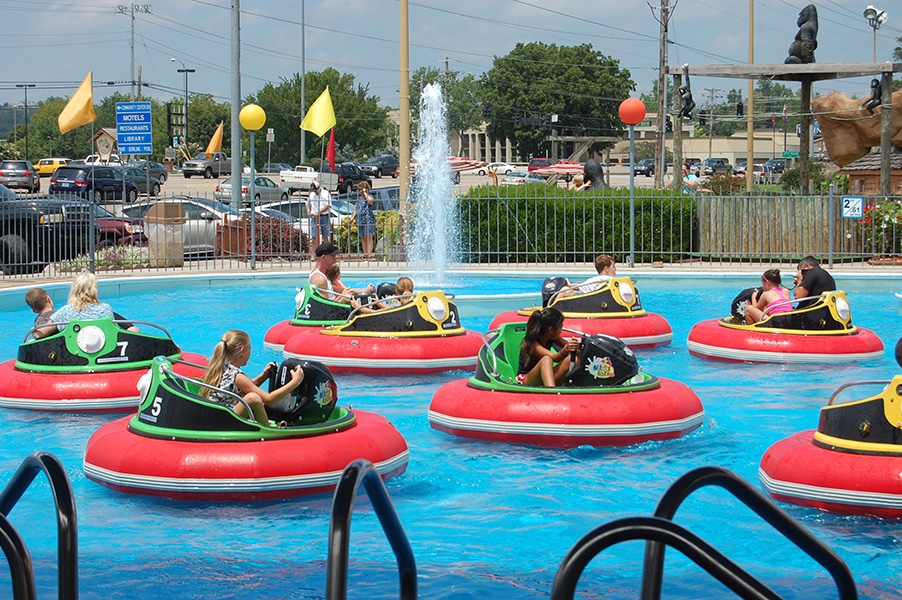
(0, 450), (78, 600)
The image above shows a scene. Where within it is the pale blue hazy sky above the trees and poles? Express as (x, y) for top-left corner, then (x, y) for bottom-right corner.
(0, 0), (902, 106)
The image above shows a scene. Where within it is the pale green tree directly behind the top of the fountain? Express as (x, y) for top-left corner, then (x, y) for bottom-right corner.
(410, 67), (483, 146)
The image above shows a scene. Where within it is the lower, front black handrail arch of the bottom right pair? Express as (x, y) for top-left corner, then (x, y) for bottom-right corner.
(551, 517), (780, 600)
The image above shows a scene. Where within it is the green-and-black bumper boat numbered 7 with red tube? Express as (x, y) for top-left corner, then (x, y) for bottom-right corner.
(0, 318), (207, 412)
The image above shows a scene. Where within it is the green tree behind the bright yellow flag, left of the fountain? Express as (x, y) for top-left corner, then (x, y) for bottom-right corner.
(255, 67), (392, 166)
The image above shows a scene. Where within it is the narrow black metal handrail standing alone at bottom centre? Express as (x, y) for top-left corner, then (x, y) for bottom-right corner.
(326, 459), (417, 600)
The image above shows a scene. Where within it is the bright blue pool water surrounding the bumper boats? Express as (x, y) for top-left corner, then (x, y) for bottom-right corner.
(0, 273), (902, 599)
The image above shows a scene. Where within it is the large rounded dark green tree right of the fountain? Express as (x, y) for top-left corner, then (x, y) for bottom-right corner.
(481, 42), (636, 156)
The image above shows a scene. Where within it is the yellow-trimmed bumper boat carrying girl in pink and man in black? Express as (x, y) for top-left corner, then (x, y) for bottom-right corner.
(687, 291), (884, 363)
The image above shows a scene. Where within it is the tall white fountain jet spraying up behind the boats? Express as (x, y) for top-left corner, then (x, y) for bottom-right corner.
(409, 83), (459, 284)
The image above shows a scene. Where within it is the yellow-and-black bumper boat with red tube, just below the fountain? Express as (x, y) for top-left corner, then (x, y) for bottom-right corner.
(283, 291), (482, 374)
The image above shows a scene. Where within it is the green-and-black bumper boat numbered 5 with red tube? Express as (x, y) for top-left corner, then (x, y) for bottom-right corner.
(84, 357), (409, 501)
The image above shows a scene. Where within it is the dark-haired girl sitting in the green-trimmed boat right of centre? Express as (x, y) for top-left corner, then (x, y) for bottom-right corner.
(517, 308), (579, 387)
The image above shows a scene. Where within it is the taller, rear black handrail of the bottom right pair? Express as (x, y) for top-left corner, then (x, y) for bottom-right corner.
(640, 466), (858, 600)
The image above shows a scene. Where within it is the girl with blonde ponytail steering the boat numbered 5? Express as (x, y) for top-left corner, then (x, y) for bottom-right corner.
(200, 329), (304, 426)
